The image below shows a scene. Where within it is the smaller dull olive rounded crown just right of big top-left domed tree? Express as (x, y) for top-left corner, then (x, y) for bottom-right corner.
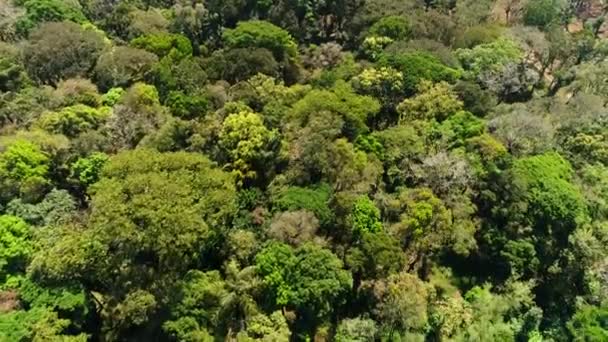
(95, 46), (158, 90)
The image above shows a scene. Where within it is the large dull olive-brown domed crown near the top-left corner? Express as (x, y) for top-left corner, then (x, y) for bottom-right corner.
(23, 22), (105, 84)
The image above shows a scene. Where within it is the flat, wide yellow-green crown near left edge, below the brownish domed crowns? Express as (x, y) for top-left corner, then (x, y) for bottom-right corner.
(36, 104), (110, 138)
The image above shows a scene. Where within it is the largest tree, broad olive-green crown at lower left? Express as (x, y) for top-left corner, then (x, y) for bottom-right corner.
(31, 150), (235, 336)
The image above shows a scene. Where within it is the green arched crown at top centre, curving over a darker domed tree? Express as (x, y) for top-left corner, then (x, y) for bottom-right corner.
(223, 20), (297, 61)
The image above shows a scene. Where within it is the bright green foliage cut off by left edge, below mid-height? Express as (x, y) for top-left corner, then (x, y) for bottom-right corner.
(0, 215), (33, 284)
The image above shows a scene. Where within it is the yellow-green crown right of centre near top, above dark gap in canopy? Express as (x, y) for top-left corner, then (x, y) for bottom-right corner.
(397, 81), (463, 122)
